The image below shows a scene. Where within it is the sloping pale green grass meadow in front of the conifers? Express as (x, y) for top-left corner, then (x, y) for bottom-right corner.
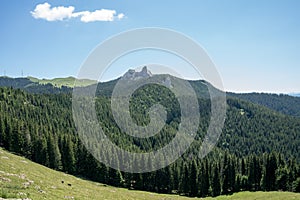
(0, 148), (300, 200)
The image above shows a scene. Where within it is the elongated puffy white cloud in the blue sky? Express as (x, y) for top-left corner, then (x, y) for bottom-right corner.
(30, 2), (125, 22)
